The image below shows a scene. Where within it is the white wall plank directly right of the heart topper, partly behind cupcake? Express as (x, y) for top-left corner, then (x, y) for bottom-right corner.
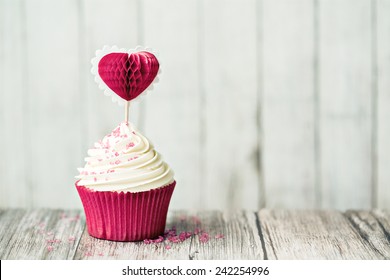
(143, 0), (204, 209)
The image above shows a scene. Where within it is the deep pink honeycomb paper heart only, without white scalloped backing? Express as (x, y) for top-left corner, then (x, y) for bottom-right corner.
(98, 51), (159, 101)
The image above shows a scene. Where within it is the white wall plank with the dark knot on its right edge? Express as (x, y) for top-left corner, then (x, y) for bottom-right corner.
(198, 0), (260, 209)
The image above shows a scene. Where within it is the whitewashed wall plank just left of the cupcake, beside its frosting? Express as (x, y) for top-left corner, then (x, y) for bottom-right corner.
(23, 0), (83, 208)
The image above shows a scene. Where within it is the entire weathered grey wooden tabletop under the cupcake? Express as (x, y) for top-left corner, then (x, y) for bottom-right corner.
(0, 209), (390, 260)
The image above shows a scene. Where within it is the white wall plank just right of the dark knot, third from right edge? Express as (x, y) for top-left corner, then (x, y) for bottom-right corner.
(261, 0), (318, 208)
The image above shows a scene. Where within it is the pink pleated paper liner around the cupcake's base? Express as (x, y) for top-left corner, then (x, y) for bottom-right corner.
(76, 181), (176, 241)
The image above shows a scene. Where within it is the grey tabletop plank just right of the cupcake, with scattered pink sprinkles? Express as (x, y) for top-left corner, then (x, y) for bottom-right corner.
(190, 211), (265, 260)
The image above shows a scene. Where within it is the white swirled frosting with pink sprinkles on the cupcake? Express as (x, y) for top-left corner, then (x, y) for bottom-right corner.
(76, 122), (174, 192)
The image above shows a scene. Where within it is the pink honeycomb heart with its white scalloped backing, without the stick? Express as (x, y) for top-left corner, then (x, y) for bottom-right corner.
(92, 46), (160, 104)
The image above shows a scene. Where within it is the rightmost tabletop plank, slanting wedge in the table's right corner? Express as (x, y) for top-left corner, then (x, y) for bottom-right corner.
(345, 210), (390, 259)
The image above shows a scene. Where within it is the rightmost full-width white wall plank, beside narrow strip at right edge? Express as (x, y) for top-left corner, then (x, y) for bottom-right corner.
(319, 0), (372, 209)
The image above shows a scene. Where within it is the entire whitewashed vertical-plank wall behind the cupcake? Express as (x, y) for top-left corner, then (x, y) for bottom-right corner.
(0, 0), (390, 209)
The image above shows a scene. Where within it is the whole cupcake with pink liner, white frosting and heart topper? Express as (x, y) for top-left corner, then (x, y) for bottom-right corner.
(76, 47), (176, 241)
